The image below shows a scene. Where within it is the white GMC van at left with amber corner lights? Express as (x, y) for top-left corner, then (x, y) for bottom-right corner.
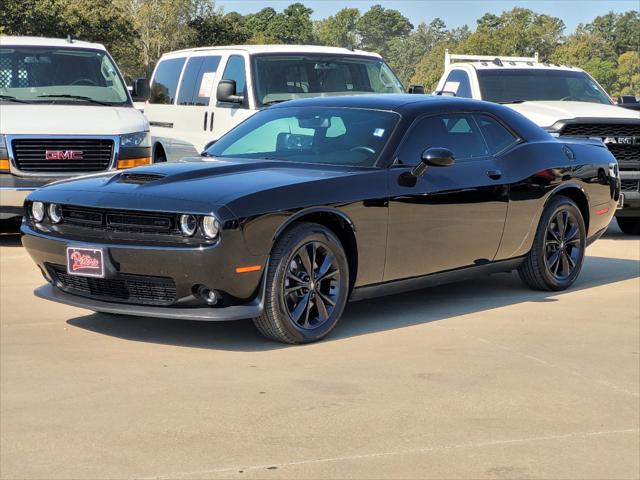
(0, 36), (151, 220)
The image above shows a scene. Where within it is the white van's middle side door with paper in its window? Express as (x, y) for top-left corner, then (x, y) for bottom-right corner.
(173, 52), (221, 153)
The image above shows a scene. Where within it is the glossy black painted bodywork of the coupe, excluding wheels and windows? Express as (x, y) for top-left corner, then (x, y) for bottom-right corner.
(22, 95), (619, 319)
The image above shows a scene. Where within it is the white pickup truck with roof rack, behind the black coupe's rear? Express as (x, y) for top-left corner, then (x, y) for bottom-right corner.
(434, 51), (640, 235)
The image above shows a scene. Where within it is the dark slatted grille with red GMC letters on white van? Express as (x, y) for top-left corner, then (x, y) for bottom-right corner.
(11, 138), (113, 173)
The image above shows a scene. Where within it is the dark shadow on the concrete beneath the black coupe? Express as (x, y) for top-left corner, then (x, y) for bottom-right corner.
(67, 257), (640, 351)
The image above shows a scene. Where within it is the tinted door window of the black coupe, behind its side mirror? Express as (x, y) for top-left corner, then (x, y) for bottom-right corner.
(399, 113), (489, 165)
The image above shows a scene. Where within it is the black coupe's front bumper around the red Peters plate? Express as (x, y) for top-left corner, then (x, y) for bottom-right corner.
(22, 222), (268, 320)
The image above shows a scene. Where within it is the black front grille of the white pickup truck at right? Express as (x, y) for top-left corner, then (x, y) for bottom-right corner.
(560, 122), (640, 170)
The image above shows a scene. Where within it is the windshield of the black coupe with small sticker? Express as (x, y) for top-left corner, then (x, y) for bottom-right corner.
(206, 107), (400, 167)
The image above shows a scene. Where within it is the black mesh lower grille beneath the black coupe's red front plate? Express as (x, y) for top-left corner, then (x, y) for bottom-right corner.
(48, 265), (176, 306)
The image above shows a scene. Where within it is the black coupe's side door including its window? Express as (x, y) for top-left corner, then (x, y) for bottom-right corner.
(385, 113), (508, 281)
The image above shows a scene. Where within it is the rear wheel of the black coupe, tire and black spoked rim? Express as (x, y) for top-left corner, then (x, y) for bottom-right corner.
(518, 196), (587, 291)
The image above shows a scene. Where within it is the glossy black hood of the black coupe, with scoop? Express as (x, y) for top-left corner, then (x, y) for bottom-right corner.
(29, 159), (370, 215)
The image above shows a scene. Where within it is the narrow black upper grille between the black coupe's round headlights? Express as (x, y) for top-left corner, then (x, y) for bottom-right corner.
(62, 205), (177, 233)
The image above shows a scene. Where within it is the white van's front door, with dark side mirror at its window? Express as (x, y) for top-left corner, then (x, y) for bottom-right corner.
(210, 54), (257, 139)
